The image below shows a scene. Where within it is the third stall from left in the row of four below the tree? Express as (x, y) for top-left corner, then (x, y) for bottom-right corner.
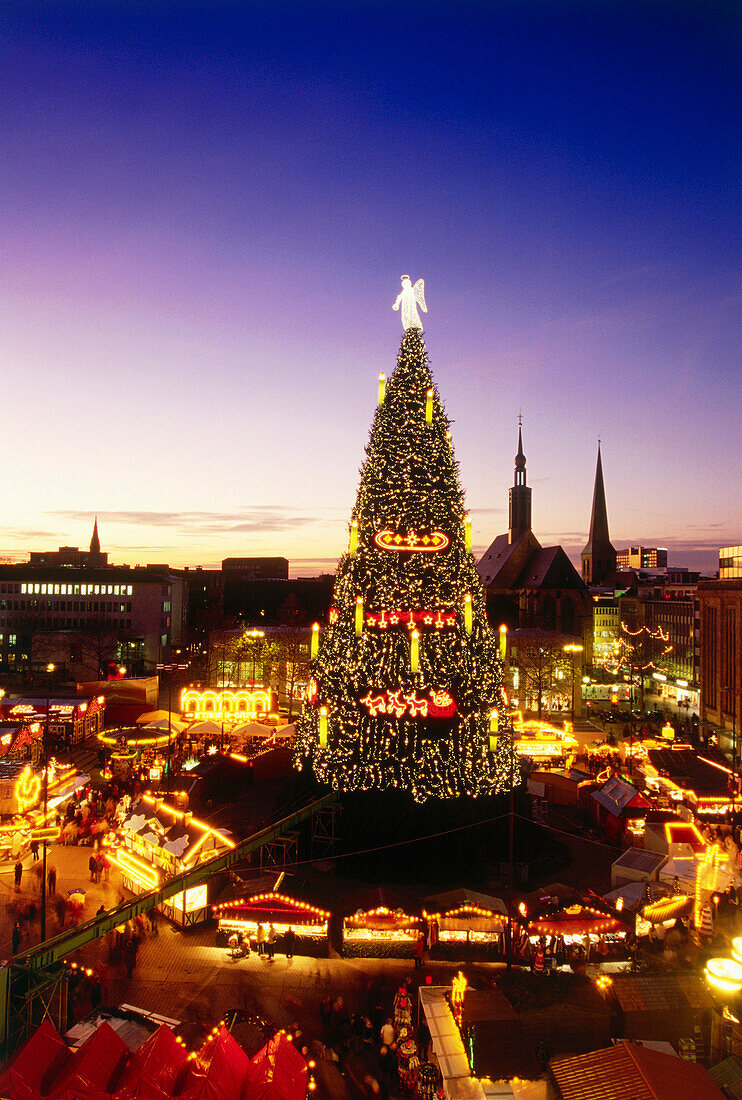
(422, 890), (508, 961)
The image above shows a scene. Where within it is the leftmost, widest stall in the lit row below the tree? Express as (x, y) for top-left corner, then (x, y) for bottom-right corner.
(212, 890), (330, 957)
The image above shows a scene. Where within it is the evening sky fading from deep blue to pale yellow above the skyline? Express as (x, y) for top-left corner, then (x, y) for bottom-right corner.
(0, 0), (742, 574)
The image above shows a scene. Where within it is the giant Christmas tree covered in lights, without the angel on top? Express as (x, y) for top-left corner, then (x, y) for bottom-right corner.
(295, 297), (509, 802)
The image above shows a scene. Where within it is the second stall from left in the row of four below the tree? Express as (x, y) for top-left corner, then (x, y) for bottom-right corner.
(343, 890), (423, 958)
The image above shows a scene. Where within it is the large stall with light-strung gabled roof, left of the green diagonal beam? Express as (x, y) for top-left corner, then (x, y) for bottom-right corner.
(110, 794), (234, 927)
